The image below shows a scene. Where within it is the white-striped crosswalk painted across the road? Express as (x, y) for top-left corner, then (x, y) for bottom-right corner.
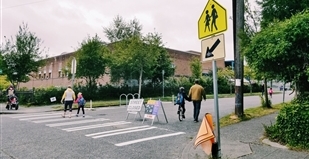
(9, 113), (185, 146)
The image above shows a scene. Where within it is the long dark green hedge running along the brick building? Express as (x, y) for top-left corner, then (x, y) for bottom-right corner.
(10, 76), (262, 105)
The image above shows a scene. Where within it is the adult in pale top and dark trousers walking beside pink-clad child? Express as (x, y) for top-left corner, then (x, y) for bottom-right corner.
(61, 86), (75, 118)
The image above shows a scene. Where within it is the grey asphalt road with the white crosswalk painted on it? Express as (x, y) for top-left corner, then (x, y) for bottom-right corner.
(0, 94), (292, 159)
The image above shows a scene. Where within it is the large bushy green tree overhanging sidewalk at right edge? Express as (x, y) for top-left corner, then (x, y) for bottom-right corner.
(244, 12), (309, 100)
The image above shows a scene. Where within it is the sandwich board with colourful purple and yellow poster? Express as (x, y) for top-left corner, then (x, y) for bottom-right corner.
(143, 100), (168, 125)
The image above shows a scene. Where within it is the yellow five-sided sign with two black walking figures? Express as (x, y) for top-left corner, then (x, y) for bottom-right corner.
(198, 0), (227, 39)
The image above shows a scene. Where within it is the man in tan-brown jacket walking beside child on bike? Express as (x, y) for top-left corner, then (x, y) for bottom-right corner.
(189, 79), (206, 123)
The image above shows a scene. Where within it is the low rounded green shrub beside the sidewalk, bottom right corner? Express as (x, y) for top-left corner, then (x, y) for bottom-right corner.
(264, 104), (309, 150)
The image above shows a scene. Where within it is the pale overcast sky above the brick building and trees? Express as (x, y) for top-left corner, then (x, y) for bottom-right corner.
(1, 0), (248, 60)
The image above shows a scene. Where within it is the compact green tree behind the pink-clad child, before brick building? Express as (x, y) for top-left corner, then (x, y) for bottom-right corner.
(74, 35), (109, 90)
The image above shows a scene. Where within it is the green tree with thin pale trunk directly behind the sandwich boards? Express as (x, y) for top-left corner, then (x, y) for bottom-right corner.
(110, 36), (159, 95)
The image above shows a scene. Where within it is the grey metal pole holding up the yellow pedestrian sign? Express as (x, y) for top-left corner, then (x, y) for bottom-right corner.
(212, 60), (221, 158)
